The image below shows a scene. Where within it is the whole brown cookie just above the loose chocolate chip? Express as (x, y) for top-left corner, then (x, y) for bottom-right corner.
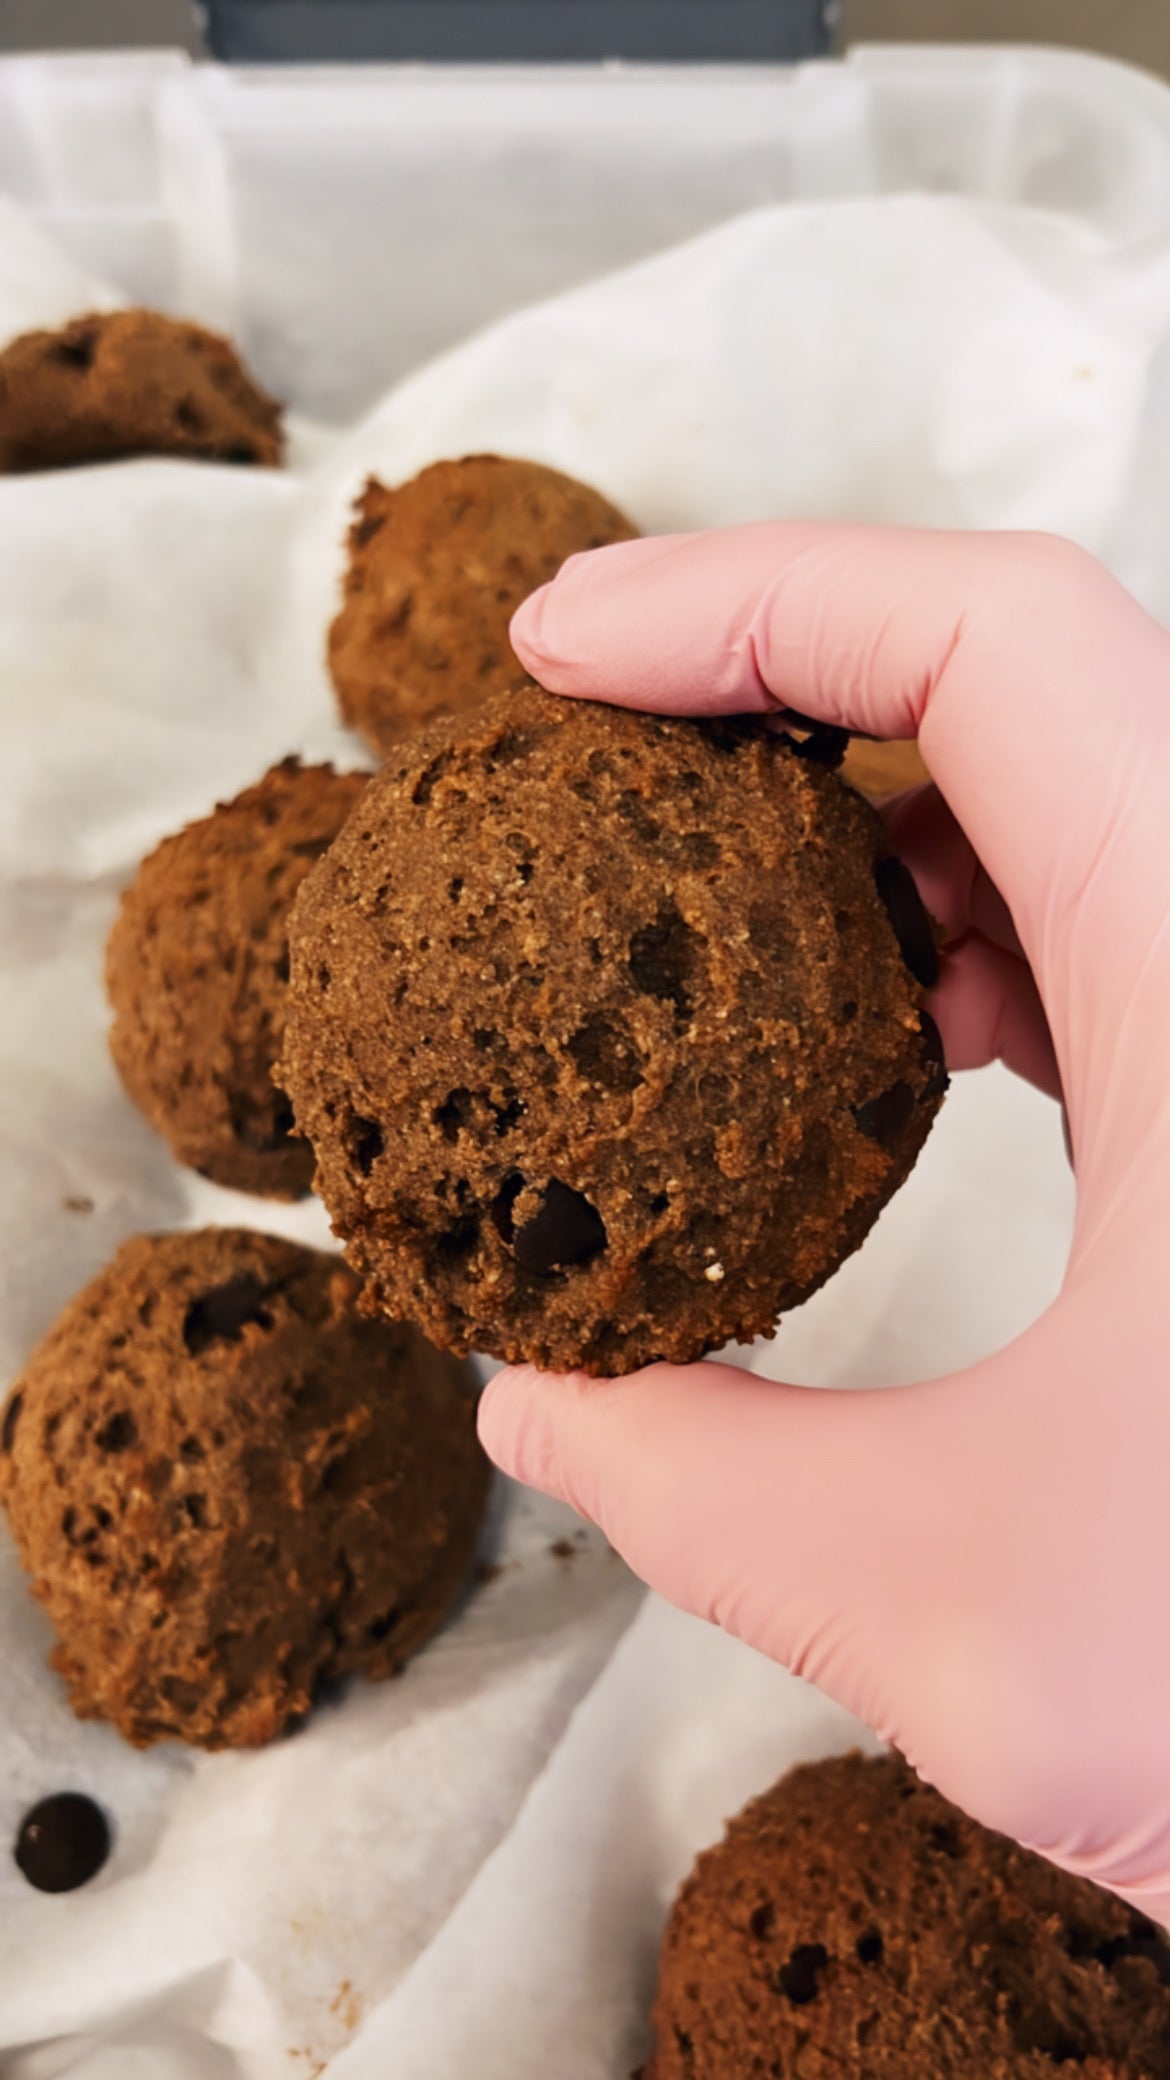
(0, 1229), (489, 1747)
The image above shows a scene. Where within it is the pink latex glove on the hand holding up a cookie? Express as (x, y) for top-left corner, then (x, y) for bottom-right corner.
(481, 524), (1170, 1922)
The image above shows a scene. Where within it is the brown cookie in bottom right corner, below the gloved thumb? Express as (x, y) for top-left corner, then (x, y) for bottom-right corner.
(643, 1756), (1170, 2080)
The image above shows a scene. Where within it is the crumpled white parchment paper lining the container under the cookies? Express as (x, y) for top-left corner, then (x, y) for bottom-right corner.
(9, 56), (1170, 2080)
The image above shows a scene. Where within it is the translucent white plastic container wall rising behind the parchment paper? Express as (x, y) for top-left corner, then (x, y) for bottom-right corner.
(0, 48), (1170, 420)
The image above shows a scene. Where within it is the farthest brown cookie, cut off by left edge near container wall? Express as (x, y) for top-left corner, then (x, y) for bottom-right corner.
(0, 310), (283, 470)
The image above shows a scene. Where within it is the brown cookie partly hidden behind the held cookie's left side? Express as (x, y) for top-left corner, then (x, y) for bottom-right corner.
(106, 759), (366, 1198)
